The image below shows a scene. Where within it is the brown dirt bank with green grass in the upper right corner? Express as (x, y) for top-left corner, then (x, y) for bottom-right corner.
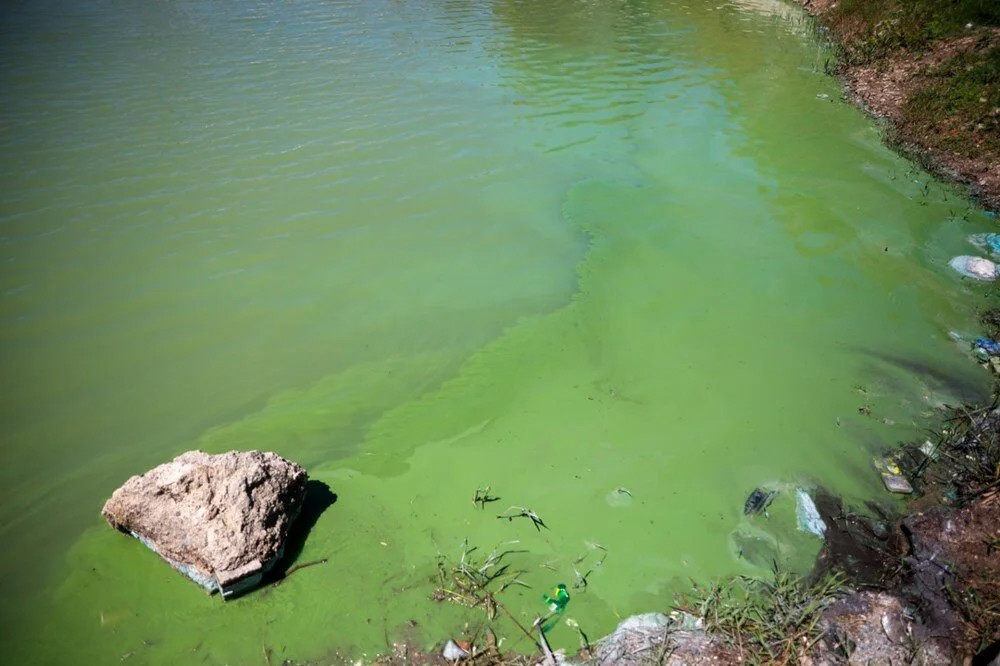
(795, 0), (1000, 210)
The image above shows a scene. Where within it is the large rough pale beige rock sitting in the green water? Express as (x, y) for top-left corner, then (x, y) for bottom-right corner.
(102, 451), (308, 597)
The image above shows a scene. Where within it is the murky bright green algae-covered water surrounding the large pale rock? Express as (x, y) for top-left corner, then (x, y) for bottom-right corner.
(0, 0), (992, 664)
